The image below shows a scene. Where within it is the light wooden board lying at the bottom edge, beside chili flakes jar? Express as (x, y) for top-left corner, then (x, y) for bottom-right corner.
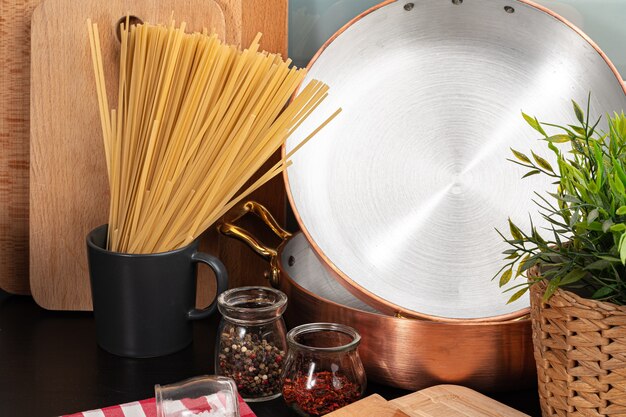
(327, 385), (528, 417)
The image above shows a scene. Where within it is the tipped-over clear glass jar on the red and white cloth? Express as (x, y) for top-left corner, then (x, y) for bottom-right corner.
(154, 375), (239, 417)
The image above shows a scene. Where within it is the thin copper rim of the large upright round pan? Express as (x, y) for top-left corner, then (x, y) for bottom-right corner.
(279, 0), (626, 324)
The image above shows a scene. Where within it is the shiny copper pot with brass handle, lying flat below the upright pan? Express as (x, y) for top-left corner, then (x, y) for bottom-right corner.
(219, 202), (536, 392)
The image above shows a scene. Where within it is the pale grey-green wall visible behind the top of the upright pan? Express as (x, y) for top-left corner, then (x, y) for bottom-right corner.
(289, 0), (626, 78)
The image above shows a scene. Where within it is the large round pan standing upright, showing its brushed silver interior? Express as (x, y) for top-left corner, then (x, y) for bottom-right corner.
(283, 0), (626, 320)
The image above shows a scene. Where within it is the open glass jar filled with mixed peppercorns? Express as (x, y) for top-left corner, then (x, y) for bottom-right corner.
(215, 287), (287, 402)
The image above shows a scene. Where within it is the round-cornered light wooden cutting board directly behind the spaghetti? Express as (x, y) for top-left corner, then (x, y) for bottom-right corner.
(30, 0), (225, 310)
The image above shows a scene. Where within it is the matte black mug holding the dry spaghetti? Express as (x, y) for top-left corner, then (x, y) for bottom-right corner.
(87, 225), (228, 358)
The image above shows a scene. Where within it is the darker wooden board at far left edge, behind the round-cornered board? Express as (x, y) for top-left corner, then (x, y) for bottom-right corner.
(0, 0), (40, 294)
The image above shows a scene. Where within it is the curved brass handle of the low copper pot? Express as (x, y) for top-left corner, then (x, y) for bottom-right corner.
(217, 201), (291, 287)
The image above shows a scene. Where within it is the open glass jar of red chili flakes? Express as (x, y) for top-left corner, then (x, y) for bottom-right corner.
(283, 323), (367, 417)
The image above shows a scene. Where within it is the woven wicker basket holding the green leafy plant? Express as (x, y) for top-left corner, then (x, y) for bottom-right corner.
(531, 282), (626, 417)
